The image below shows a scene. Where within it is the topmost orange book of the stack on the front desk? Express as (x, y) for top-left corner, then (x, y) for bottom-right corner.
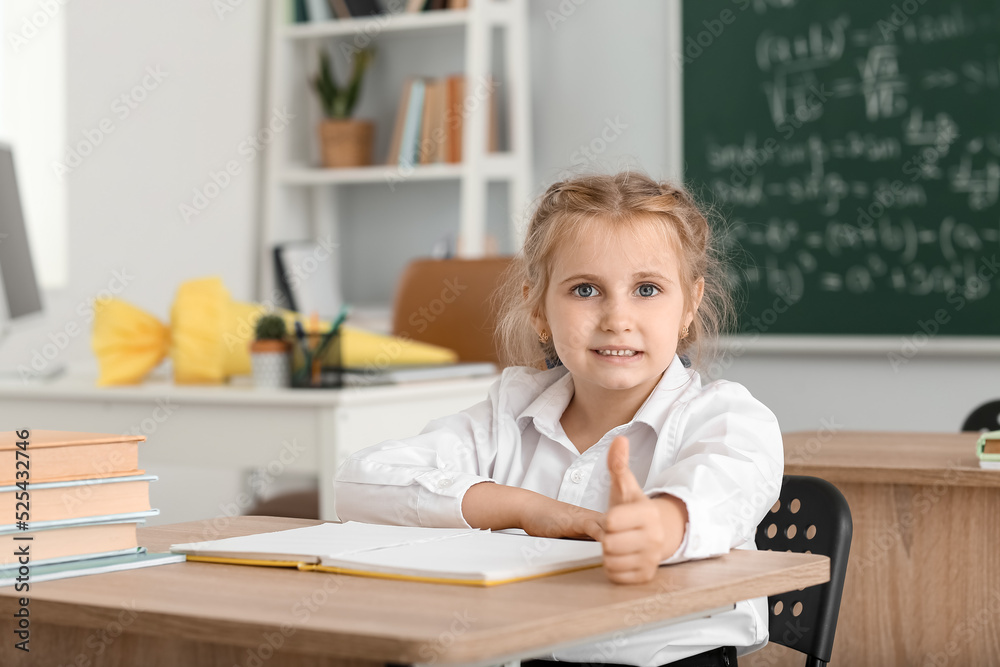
(0, 429), (146, 485)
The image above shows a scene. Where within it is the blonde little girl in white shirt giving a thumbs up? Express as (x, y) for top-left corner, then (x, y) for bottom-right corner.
(335, 171), (783, 667)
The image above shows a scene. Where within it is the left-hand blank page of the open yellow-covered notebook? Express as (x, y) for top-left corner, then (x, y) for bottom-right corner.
(170, 521), (481, 563)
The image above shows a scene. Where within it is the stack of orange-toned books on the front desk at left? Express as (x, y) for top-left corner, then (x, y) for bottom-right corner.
(0, 430), (181, 590)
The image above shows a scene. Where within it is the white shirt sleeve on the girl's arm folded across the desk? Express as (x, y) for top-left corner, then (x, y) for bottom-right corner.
(333, 378), (501, 528)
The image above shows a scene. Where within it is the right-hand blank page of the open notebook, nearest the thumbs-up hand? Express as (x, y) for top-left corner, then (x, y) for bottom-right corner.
(322, 531), (603, 581)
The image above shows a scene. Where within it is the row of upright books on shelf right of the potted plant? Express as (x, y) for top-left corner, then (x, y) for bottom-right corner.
(386, 74), (499, 167)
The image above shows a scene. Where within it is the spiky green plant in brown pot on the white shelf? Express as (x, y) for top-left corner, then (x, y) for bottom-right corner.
(312, 48), (375, 167)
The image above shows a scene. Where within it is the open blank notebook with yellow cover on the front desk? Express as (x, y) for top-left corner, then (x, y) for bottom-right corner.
(170, 521), (603, 586)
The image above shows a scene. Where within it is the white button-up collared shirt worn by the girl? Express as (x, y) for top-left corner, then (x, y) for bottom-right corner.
(334, 356), (784, 667)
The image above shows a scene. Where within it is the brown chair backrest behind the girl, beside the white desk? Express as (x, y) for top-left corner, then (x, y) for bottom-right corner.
(392, 256), (511, 364)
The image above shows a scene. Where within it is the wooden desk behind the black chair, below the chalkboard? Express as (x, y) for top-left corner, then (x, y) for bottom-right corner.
(756, 431), (1000, 667)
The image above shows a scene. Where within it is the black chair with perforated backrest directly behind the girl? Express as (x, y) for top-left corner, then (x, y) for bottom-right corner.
(755, 475), (854, 667)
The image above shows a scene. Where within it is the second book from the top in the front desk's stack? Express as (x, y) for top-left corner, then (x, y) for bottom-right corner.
(0, 475), (157, 522)
